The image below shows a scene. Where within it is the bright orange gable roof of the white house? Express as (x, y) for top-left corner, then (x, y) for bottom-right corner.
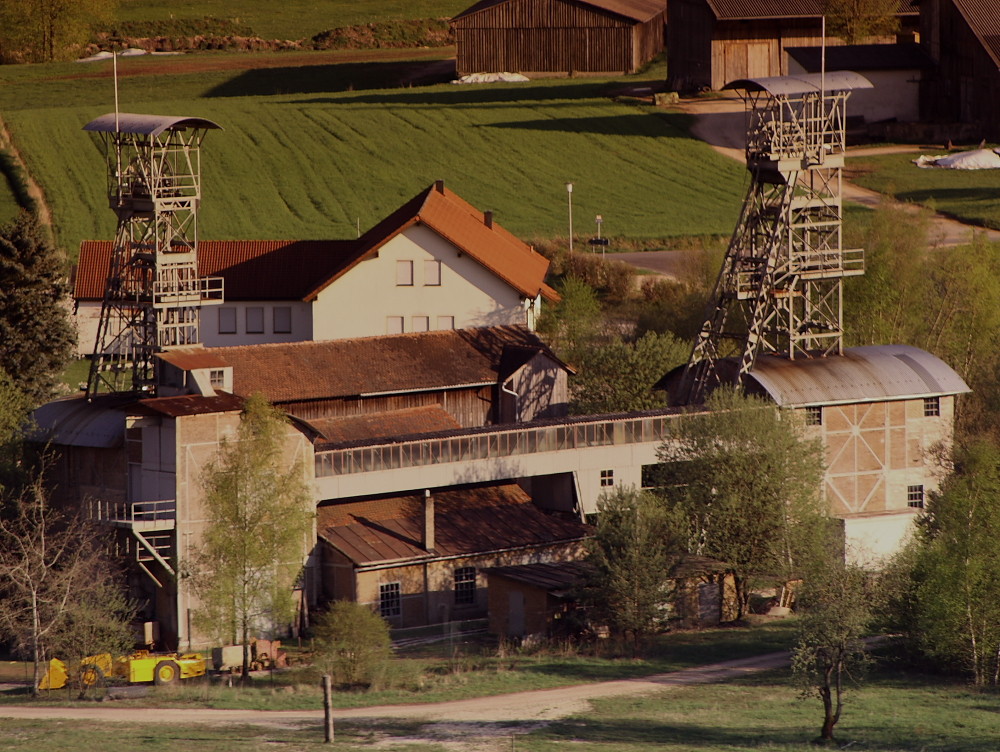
(305, 180), (559, 300)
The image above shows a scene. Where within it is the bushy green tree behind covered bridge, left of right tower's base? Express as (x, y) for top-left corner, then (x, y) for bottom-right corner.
(570, 332), (691, 415)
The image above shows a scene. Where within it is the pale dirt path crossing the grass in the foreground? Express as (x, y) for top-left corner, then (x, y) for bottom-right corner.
(0, 652), (789, 738)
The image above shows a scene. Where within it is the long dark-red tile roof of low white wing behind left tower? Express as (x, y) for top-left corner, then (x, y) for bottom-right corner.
(73, 240), (357, 300)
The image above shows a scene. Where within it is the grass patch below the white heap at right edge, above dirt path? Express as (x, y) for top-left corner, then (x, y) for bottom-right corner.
(847, 152), (1000, 230)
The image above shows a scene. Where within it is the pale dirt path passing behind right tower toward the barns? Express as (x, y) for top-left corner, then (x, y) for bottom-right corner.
(672, 93), (1000, 250)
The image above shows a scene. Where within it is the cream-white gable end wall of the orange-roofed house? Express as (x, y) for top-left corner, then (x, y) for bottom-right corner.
(313, 225), (526, 340)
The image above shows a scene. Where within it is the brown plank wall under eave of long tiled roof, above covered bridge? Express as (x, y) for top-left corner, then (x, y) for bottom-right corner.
(281, 386), (494, 428)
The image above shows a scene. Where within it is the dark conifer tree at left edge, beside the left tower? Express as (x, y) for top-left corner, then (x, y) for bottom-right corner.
(0, 212), (75, 405)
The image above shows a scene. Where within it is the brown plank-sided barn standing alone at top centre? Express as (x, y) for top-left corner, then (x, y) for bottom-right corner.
(451, 0), (667, 76)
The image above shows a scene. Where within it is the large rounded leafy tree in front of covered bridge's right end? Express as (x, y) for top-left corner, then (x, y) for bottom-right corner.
(659, 389), (828, 619)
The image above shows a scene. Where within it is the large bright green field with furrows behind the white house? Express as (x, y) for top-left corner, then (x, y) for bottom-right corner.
(0, 55), (745, 256)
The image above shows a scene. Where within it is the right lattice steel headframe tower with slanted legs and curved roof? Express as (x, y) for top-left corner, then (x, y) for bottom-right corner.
(671, 71), (871, 404)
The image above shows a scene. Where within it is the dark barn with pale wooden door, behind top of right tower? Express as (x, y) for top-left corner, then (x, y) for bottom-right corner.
(667, 0), (917, 91)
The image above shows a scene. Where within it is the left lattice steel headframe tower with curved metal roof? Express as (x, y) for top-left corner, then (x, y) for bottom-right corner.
(84, 113), (223, 399)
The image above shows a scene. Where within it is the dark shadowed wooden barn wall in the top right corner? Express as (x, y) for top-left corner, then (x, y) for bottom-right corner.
(921, 0), (1000, 141)
